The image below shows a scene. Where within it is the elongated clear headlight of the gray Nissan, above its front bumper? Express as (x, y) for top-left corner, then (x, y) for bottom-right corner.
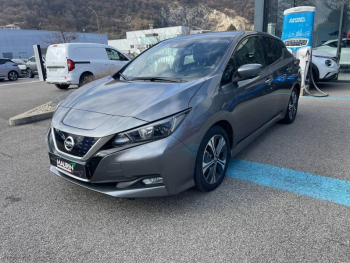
(112, 110), (190, 147)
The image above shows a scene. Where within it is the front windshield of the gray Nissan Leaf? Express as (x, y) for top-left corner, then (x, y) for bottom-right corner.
(120, 36), (234, 81)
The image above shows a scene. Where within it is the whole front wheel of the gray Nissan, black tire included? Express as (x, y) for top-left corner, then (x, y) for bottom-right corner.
(194, 126), (230, 192)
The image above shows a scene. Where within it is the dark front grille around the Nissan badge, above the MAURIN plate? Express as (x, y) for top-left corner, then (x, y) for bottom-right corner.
(53, 129), (98, 157)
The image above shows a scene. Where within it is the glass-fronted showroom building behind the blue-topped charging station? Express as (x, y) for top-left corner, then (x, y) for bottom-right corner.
(254, 0), (350, 80)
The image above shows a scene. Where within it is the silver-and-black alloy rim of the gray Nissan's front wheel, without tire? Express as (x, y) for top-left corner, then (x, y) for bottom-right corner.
(202, 135), (228, 184)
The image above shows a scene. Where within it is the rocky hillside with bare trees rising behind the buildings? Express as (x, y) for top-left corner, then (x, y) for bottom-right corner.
(0, 0), (254, 39)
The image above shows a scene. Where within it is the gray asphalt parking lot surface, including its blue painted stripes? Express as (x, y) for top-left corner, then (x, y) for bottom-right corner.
(0, 80), (350, 262)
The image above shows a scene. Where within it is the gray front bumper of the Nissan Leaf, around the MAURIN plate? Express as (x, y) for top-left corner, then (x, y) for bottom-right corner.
(47, 130), (196, 197)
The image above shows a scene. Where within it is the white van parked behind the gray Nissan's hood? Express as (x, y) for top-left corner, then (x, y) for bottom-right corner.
(46, 43), (129, 89)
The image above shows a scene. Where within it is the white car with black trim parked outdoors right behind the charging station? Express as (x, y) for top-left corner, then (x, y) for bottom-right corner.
(312, 50), (340, 82)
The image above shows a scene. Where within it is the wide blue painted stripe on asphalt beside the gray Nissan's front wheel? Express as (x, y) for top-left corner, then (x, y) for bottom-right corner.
(226, 159), (350, 206)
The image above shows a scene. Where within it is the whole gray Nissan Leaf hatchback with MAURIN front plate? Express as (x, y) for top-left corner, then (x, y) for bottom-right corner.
(46, 32), (300, 197)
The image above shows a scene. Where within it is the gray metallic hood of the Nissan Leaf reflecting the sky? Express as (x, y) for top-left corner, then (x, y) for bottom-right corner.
(52, 77), (205, 137)
